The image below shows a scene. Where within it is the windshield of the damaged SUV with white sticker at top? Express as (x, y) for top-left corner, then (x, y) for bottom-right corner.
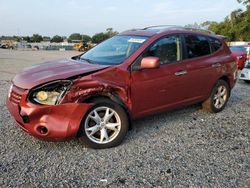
(80, 35), (148, 65)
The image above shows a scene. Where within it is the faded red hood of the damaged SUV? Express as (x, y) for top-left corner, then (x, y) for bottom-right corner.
(12, 59), (109, 89)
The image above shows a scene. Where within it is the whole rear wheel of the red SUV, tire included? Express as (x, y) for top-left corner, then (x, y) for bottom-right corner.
(202, 80), (230, 113)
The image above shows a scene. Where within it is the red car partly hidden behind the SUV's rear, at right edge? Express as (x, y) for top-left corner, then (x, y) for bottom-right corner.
(230, 45), (250, 70)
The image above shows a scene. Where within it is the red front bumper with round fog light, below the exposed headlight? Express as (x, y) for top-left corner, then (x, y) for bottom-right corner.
(6, 86), (92, 140)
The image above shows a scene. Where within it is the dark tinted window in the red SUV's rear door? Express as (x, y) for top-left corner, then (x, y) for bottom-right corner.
(185, 35), (211, 58)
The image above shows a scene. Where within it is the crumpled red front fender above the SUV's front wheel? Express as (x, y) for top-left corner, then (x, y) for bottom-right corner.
(63, 68), (131, 111)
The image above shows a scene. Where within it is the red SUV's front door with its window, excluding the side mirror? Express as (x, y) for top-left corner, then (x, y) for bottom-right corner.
(131, 36), (188, 117)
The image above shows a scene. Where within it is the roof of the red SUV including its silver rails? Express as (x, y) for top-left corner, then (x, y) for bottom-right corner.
(119, 25), (217, 38)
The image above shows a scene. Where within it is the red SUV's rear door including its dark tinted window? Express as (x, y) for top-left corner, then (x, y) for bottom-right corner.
(183, 35), (223, 98)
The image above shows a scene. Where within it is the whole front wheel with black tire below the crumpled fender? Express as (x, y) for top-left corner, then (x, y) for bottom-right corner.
(80, 99), (129, 149)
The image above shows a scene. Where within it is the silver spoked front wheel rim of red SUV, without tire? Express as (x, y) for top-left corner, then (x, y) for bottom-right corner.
(84, 106), (121, 144)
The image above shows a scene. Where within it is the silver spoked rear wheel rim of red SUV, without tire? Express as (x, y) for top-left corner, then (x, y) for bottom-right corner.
(213, 85), (228, 109)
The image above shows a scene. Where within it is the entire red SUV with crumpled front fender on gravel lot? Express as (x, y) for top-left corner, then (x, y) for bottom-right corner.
(7, 26), (237, 148)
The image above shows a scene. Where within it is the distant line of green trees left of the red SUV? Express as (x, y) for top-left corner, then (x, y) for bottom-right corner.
(0, 28), (118, 43)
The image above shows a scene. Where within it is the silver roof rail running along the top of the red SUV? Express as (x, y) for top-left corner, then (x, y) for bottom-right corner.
(142, 25), (215, 35)
